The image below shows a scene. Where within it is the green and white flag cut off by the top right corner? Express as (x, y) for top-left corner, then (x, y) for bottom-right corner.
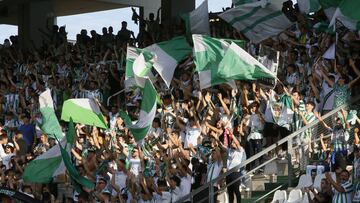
(330, 0), (360, 30)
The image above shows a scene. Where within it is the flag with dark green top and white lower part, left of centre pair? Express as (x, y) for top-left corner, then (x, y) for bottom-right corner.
(145, 36), (192, 87)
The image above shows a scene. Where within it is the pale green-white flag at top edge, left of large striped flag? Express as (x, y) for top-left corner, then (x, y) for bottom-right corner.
(181, 0), (210, 38)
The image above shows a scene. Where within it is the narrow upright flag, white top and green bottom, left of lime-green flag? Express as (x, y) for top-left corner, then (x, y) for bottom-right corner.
(39, 89), (63, 140)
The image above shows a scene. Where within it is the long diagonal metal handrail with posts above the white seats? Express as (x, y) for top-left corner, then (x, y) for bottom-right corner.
(177, 95), (360, 203)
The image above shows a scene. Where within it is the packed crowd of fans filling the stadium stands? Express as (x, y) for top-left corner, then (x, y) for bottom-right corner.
(0, 1), (360, 203)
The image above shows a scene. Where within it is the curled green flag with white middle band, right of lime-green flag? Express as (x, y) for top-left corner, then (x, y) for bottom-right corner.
(120, 79), (157, 142)
